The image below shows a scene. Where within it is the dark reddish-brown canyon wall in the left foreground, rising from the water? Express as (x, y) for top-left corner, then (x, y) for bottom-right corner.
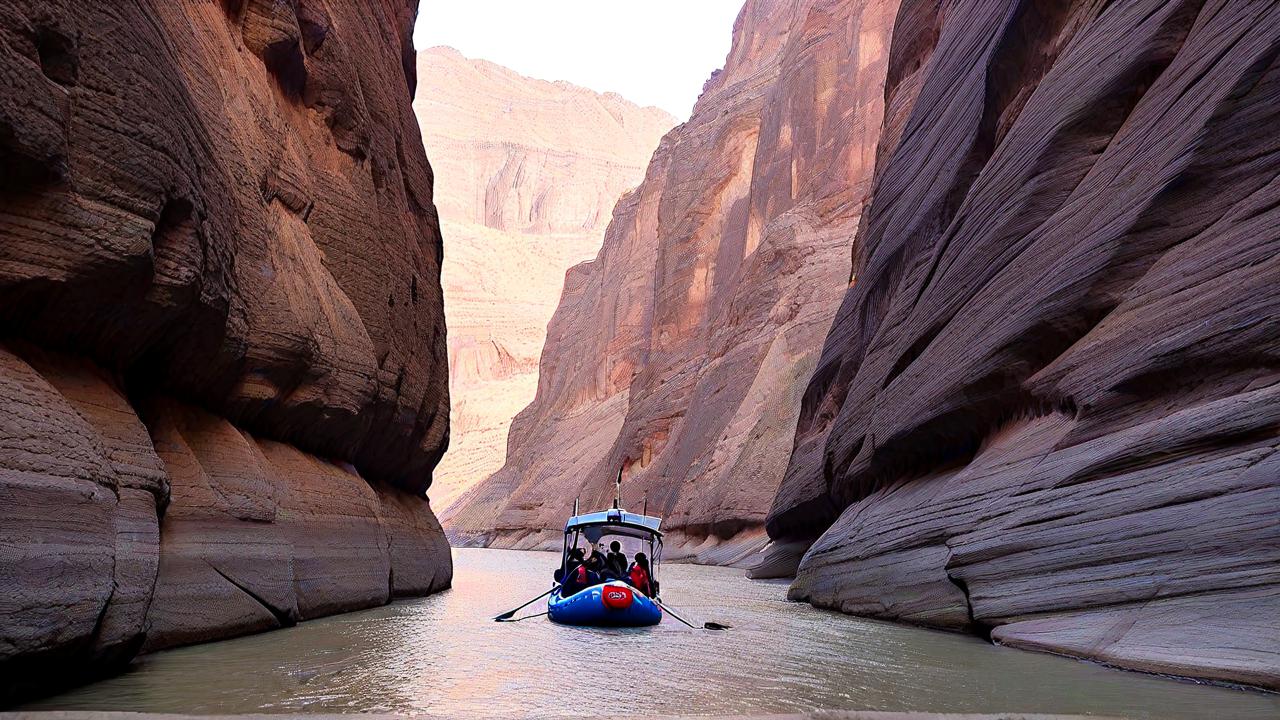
(0, 0), (451, 694)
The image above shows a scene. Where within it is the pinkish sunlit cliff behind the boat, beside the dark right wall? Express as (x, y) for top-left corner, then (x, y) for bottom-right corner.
(443, 0), (896, 562)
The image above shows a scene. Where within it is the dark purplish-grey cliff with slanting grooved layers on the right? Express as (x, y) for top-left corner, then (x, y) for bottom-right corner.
(768, 0), (1280, 688)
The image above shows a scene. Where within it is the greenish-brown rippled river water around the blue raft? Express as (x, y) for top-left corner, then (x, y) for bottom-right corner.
(32, 550), (1280, 720)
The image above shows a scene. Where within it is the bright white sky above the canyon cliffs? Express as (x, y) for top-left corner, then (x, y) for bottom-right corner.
(413, 0), (742, 120)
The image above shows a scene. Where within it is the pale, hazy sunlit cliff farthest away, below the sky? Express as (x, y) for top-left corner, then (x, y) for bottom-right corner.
(413, 47), (676, 507)
